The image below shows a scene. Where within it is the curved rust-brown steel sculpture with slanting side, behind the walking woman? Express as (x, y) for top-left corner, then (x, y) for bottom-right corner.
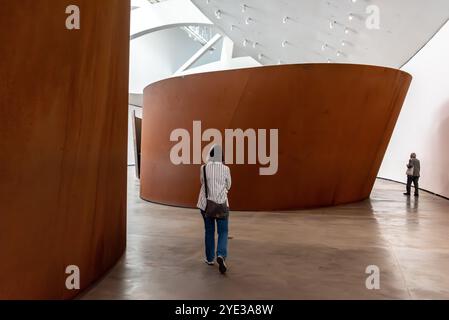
(141, 64), (411, 210)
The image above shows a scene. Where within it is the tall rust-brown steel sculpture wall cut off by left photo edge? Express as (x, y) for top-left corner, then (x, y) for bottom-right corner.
(0, 0), (130, 299)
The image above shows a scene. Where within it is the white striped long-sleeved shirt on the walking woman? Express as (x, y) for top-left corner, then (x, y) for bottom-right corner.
(197, 162), (231, 211)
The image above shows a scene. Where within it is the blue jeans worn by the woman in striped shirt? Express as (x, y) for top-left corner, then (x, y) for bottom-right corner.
(201, 210), (229, 262)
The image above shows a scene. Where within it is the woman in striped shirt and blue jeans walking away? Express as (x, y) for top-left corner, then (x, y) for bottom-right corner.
(198, 144), (231, 273)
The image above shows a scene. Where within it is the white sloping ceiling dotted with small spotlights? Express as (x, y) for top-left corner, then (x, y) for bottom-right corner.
(192, 0), (449, 68)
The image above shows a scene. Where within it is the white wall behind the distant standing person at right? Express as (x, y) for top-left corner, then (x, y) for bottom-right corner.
(379, 23), (449, 197)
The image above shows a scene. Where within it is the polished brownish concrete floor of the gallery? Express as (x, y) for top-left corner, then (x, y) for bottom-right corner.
(80, 168), (449, 300)
